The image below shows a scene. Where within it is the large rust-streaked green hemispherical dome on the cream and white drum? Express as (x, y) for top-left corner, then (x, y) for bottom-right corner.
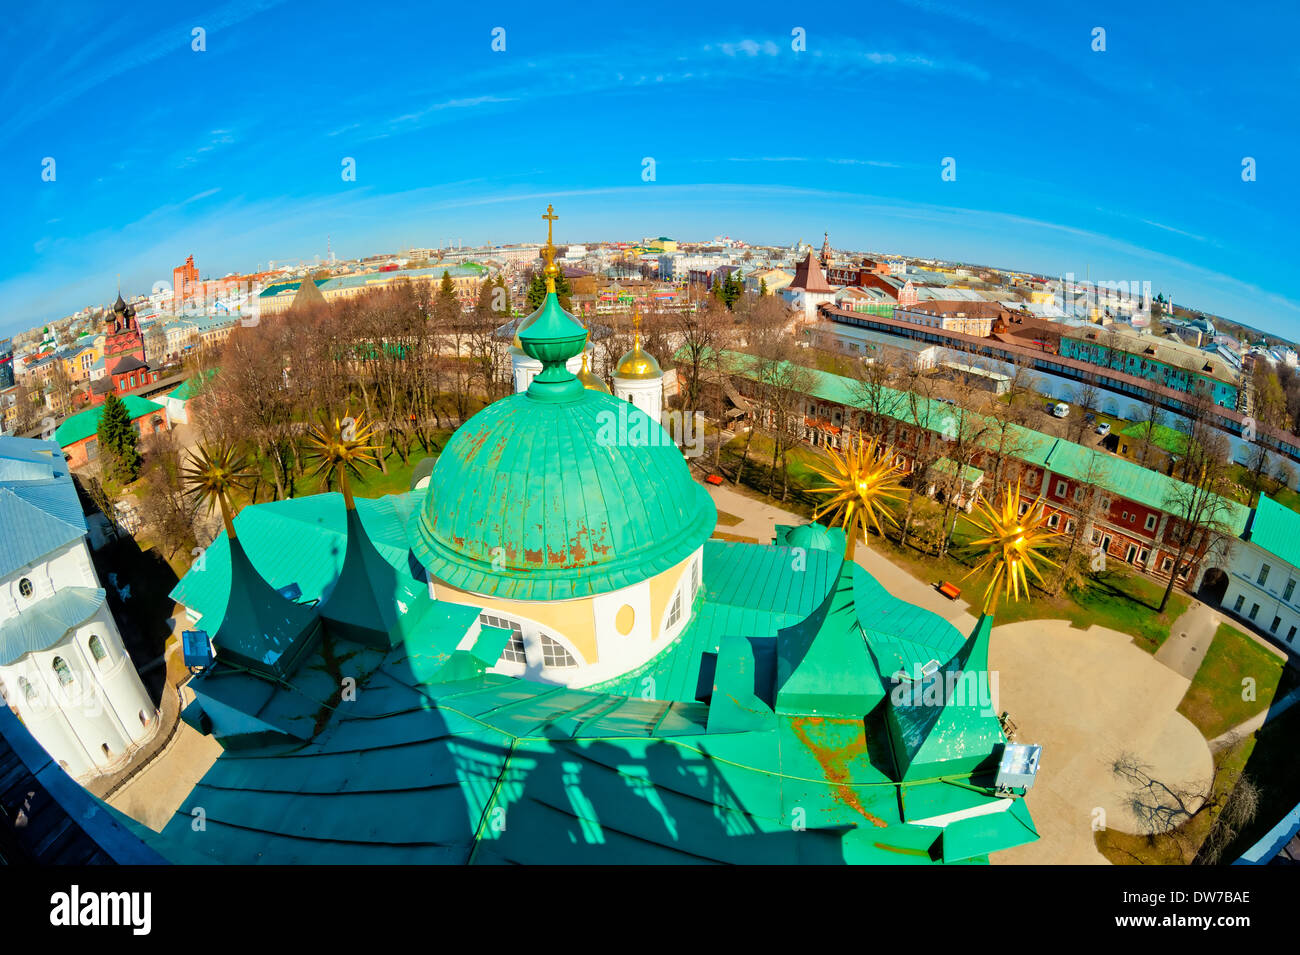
(412, 387), (718, 600)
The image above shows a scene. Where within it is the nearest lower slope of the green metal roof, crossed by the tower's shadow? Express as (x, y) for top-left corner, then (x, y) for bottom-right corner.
(153, 650), (1036, 864)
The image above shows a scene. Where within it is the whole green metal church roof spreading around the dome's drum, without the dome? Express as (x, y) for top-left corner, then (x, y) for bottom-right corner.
(155, 485), (1036, 864)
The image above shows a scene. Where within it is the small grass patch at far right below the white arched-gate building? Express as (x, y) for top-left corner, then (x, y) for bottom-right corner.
(1178, 624), (1282, 739)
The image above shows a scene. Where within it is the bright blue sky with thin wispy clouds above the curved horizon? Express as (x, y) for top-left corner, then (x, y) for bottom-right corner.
(0, 0), (1300, 338)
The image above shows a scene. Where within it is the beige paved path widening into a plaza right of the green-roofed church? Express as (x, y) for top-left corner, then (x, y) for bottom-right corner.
(709, 486), (1218, 865)
